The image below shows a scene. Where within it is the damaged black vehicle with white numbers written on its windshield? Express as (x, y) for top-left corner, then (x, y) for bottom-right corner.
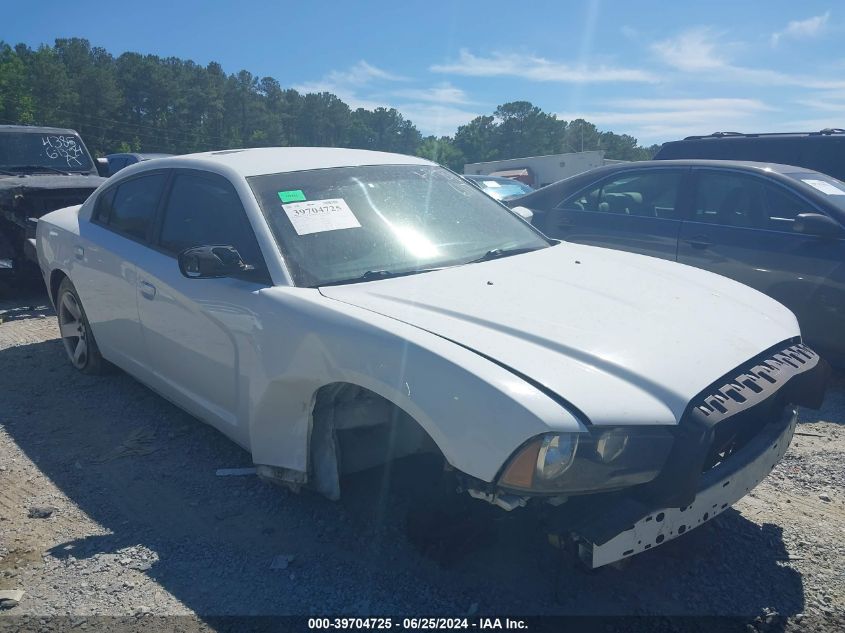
(0, 125), (105, 283)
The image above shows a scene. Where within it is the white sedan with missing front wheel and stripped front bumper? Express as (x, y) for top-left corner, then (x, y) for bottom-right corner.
(37, 148), (826, 566)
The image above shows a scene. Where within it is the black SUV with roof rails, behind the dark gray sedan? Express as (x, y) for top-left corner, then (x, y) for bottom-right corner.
(654, 128), (845, 181)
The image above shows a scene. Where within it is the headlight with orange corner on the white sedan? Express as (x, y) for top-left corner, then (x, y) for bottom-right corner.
(498, 427), (674, 494)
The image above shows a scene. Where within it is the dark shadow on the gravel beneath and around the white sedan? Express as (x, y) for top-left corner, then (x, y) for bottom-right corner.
(0, 336), (804, 618)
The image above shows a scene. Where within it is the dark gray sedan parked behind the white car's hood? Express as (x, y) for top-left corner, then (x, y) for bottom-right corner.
(507, 160), (845, 365)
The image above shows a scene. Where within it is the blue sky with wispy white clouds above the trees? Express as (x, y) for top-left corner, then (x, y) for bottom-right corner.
(0, 0), (845, 144)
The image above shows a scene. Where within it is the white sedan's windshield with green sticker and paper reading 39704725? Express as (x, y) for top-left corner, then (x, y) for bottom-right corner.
(248, 165), (550, 286)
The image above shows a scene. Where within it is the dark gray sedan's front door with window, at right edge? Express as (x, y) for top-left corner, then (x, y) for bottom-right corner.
(678, 169), (845, 350)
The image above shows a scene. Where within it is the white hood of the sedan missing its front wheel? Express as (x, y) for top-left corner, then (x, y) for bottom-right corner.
(320, 243), (799, 425)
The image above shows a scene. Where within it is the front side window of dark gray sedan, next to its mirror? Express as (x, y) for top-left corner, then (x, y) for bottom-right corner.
(694, 172), (816, 232)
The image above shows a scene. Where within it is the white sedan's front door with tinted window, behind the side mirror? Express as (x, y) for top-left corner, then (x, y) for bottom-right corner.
(138, 169), (269, 443)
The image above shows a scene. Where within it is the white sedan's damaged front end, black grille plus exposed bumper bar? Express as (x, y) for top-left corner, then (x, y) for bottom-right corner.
(549, 343), (830, 568)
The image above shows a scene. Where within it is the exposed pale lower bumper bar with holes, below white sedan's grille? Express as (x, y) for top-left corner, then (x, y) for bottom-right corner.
(573, 408), (798, 568)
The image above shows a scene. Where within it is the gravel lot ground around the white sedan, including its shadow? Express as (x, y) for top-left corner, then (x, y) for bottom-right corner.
(0, 293), (845, 631)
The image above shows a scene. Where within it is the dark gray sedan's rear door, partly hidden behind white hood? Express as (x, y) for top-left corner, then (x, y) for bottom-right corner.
(545, 167), (689, 260)
